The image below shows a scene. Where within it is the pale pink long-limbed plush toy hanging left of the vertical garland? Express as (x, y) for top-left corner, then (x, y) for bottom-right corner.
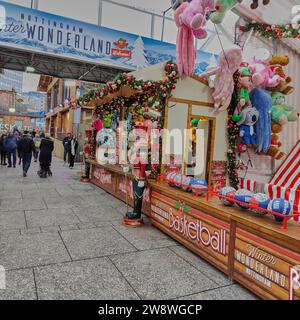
(200, 48), (243, 111)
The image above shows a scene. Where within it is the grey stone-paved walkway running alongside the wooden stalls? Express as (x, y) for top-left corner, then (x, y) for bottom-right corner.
(0, 159), (255, 300)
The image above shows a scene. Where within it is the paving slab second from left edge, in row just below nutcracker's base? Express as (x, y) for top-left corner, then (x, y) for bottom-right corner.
(61, 227), (136, 260)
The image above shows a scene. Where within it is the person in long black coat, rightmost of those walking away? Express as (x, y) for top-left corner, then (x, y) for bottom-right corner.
(38, 134), (54, 178)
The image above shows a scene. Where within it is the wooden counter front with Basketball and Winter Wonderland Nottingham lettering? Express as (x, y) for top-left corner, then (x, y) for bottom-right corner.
(149, 181), (300, 300)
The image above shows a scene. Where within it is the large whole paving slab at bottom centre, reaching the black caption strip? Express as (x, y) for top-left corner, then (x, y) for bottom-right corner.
(110, 248), (218, 300)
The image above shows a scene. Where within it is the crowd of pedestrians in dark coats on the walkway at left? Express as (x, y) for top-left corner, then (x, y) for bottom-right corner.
(0, 129), (79, 178)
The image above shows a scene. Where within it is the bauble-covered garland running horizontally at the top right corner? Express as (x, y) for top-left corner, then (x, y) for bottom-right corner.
(245, 22), (300, 39)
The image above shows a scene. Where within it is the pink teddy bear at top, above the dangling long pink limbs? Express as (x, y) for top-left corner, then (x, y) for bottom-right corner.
(179, 0), (214, 39)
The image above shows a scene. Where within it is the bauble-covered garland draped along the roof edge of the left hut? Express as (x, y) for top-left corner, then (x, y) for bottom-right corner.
(80, 61), (178, 103)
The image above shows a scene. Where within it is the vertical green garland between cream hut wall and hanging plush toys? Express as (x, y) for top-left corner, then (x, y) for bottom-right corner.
(227, 74), (240, 189)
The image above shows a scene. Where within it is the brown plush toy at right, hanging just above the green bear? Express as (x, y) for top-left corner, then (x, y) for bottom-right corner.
(266, 55), (295, 95)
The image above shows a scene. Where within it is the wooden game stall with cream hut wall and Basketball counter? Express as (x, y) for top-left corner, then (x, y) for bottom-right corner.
(85, 65), (300, 300)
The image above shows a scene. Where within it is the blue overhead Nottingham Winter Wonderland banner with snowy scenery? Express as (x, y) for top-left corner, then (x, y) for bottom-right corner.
(0, 1), (215, 73)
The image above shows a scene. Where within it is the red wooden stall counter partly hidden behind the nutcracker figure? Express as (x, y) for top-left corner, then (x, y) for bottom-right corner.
(89, 160), (151, 216)
